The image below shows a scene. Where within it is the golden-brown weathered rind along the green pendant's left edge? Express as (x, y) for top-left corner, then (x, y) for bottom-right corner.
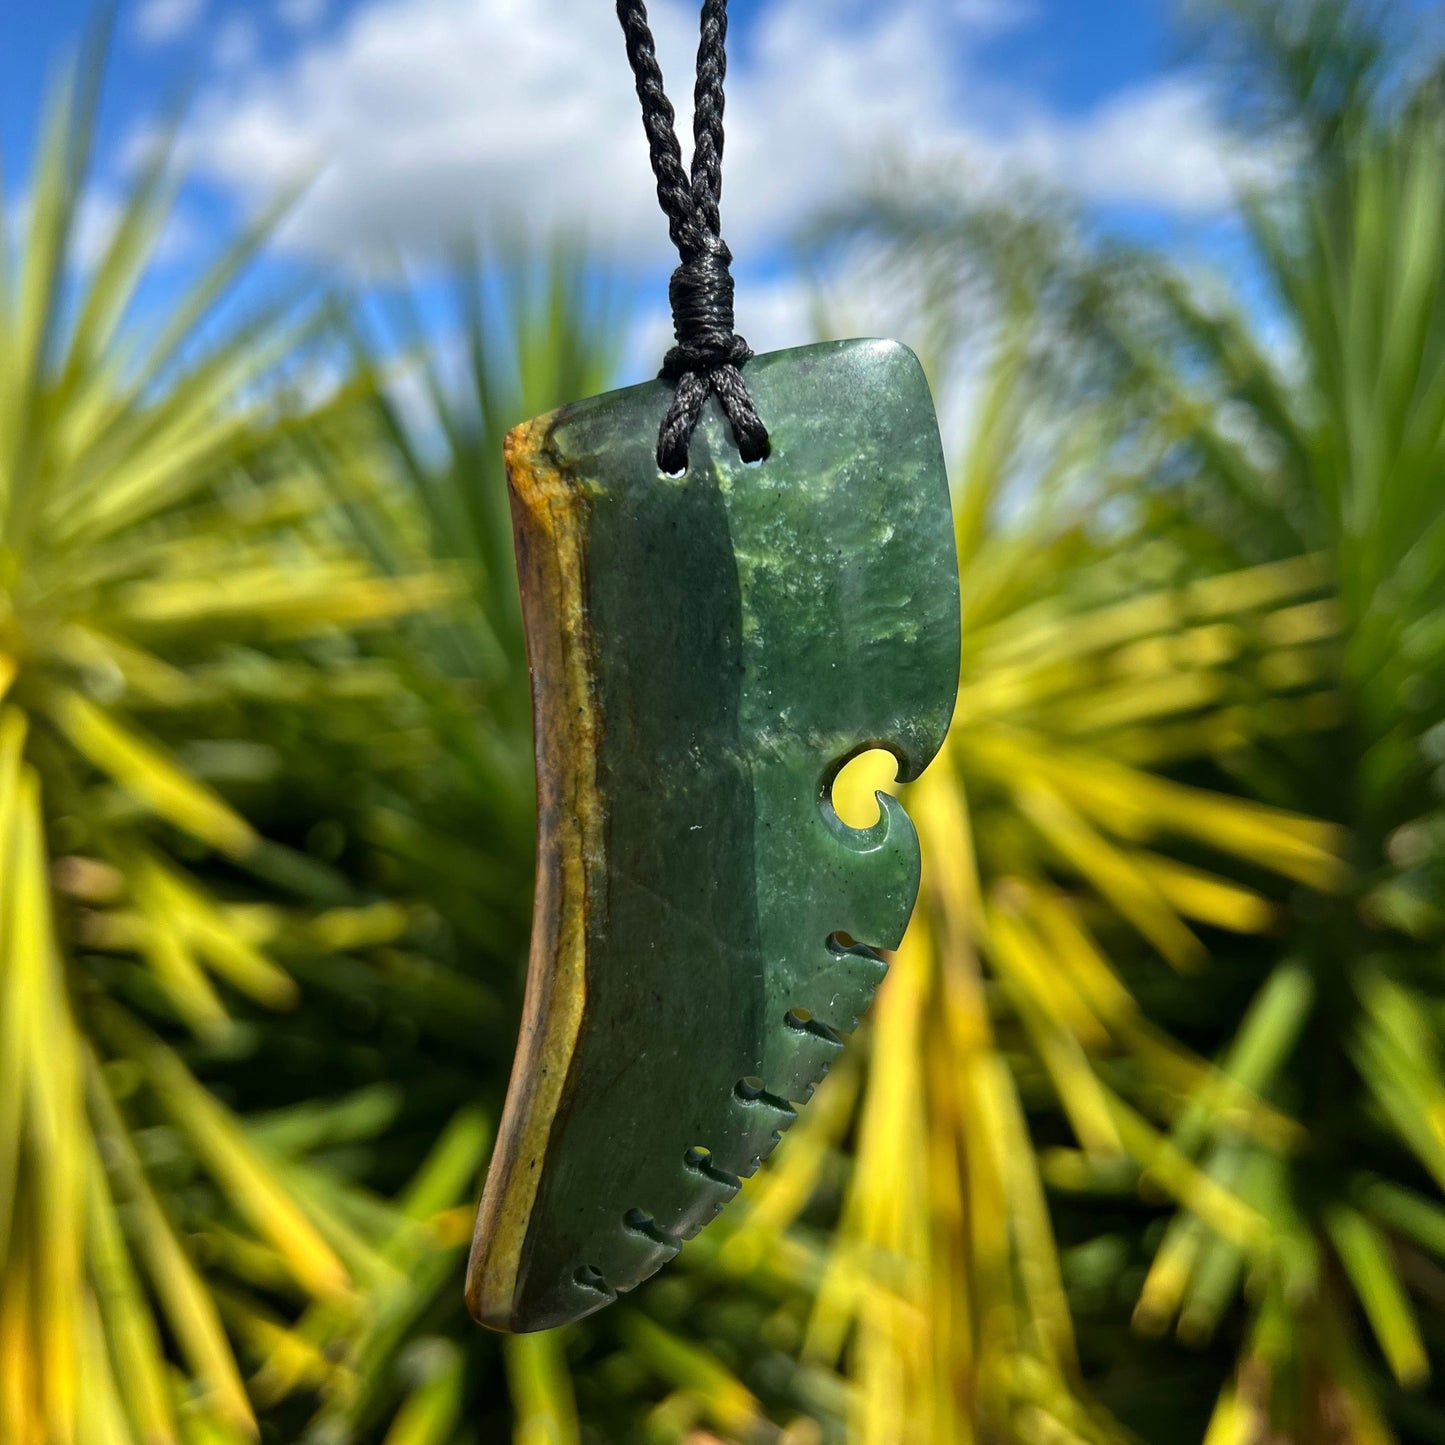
(467, 416), (601, 1331)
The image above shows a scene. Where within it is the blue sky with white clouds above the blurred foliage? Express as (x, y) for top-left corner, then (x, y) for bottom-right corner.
(0, 0), (1329, 378)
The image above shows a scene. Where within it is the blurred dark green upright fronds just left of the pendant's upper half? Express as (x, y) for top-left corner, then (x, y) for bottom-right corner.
(342, 241), (626, 948)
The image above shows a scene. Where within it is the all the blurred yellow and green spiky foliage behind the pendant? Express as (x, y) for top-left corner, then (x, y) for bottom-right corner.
(0, 0), (1445, 1445)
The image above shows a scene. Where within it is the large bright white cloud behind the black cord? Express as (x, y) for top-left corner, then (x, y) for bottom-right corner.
(177, 0), (1254, 271)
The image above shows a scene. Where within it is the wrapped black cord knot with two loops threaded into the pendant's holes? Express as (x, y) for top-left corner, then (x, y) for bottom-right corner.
(657, 231), (767, 475)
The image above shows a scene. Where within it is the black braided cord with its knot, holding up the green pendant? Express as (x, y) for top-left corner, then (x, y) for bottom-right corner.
(617, 0), (767, 475)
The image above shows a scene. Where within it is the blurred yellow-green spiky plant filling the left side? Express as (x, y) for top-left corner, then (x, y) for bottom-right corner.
(0, 49), (480, 1445)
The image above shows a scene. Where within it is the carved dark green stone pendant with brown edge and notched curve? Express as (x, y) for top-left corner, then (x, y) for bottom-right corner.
(467, 341), (958, 1331)
